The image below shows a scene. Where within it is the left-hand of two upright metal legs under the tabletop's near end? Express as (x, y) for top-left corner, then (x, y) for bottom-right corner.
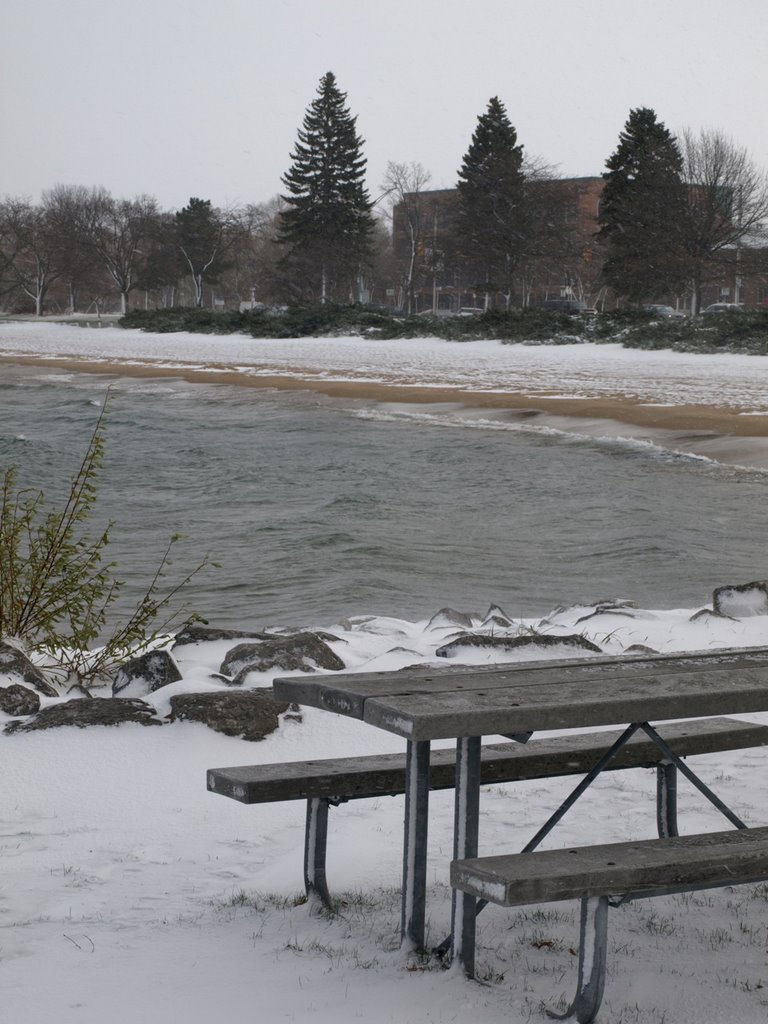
(400, 739), (429, 949)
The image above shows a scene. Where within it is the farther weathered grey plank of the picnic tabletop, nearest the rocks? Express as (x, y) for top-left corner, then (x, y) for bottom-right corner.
(273, 647), (768, 718)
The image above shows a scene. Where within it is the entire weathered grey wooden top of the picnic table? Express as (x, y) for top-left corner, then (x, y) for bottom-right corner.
(274, 647), (768, 741)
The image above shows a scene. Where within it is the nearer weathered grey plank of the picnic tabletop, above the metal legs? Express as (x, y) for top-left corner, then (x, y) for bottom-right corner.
(364, 669), (768, 739)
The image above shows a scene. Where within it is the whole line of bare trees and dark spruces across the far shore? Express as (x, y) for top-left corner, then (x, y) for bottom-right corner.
(0, 72), (768, 314)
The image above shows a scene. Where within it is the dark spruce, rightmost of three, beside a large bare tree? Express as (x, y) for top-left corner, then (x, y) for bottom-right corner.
(598, 106), (687, 302)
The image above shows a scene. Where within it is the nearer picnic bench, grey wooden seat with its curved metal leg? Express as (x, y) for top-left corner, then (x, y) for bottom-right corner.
(451, 827), (768, 1024)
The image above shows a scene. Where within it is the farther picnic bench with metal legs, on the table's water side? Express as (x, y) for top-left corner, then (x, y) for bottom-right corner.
(207, 718), (768, 906)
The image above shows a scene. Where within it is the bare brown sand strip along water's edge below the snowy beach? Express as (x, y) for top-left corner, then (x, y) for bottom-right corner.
(0, 352), (768, 470)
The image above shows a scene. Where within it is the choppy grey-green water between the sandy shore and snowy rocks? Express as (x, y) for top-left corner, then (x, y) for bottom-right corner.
(0, 366), (768, 626)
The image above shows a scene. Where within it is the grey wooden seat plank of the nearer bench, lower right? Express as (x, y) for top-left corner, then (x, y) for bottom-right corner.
(451, 827), (768, 906)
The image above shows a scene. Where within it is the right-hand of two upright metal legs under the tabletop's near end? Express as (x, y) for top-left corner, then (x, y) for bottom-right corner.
(451, 736), (481, 978)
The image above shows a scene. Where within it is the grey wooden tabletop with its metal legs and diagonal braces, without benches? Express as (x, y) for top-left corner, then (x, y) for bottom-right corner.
(273, 648), (768, 1019)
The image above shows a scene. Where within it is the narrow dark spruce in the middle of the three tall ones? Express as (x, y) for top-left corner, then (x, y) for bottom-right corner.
(458, 96), (528, 306)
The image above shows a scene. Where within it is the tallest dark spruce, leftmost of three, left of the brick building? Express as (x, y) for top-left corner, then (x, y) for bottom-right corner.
(278, 72), (374, 302)
